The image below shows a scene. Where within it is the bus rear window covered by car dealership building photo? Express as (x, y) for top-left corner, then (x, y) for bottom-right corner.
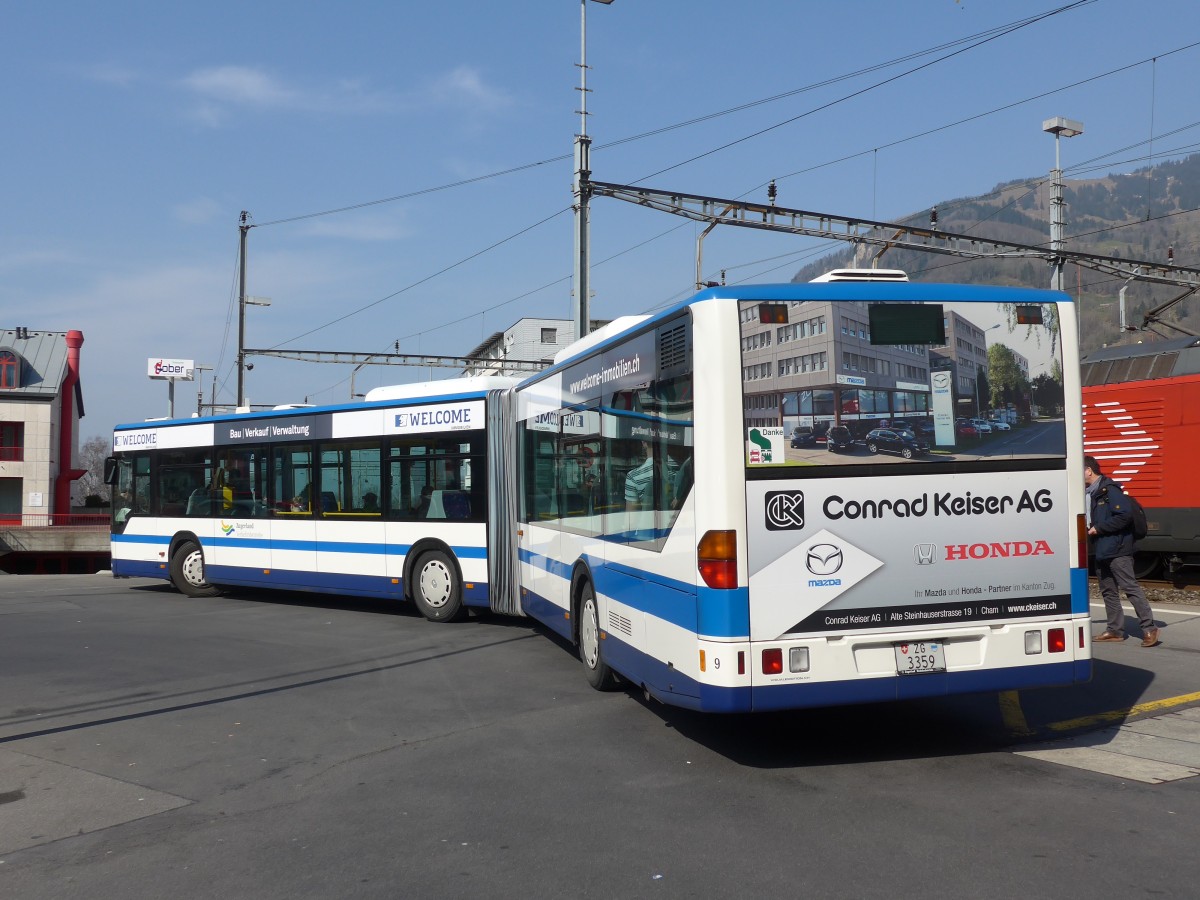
(739, 297), (1067, 469)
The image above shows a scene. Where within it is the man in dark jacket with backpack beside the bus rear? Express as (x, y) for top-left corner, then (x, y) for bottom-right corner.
(1084, 456), (1158, 647)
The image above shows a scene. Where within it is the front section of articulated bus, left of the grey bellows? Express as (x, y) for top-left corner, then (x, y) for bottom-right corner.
(110, 378), (516, 620)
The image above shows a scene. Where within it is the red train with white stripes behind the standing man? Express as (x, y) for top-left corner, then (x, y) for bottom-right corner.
(1081, 337), (1200, 577)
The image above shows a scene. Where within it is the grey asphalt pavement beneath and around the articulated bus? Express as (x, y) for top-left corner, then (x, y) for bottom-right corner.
(0, 576), (1200, 900)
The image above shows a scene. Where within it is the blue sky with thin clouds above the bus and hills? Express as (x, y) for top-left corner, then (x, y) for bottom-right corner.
(0, 0), (1200, 438)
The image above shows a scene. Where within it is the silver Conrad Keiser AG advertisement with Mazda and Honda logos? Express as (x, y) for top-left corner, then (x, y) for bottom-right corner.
(746, 470), (1073, 640)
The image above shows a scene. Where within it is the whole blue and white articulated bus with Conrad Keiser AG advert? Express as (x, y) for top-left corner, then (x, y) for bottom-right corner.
(113, 281), (1091, 712)
